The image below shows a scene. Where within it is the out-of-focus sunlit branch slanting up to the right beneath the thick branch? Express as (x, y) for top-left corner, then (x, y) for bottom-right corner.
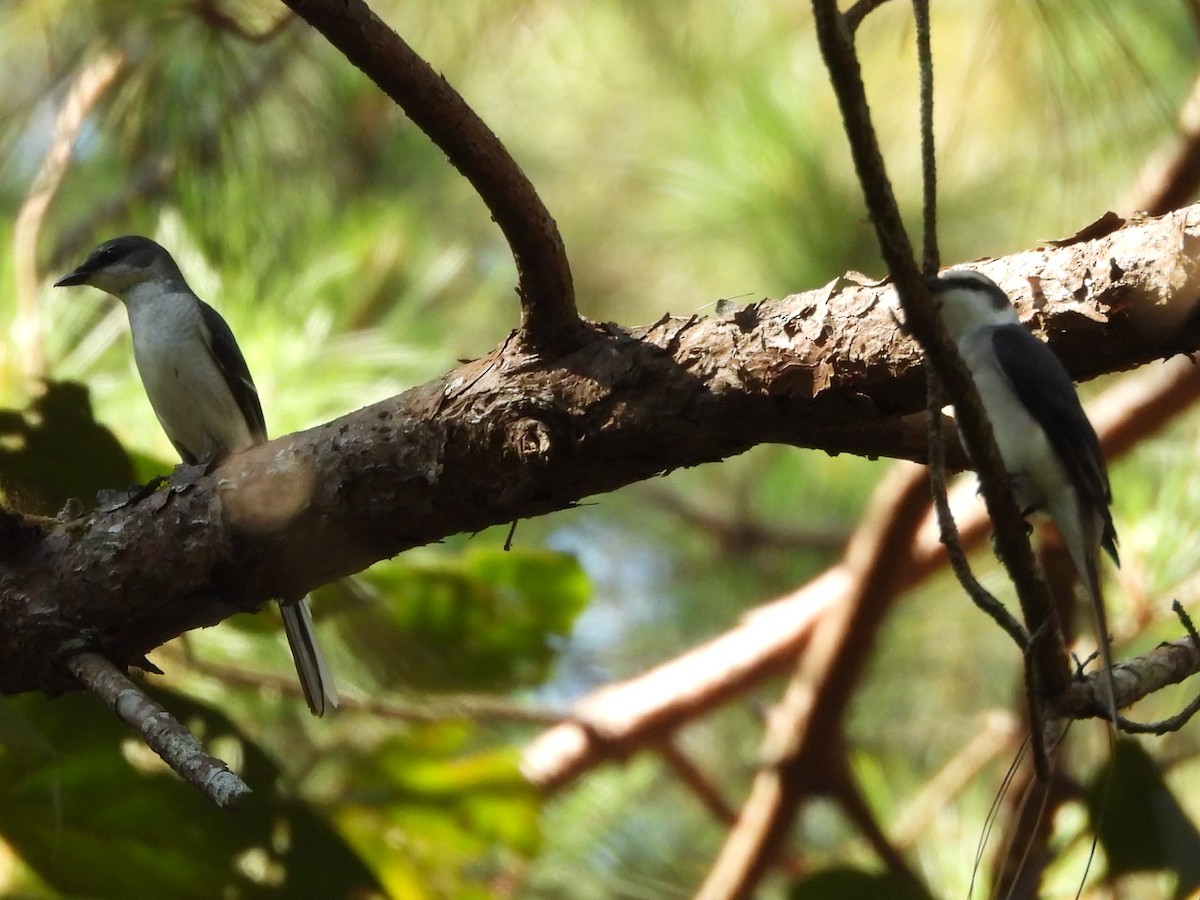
(522, 360), (1200, 792)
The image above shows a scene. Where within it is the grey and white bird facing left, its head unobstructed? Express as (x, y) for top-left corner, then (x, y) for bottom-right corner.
(54, 235), (337, 716)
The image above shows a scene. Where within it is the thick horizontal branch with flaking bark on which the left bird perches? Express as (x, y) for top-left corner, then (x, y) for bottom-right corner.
(7, 208), (1200, 692)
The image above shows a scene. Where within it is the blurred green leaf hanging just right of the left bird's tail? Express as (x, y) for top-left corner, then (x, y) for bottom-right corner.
(338, 548), (592, 691)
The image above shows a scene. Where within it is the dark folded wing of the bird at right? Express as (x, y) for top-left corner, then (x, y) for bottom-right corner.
(991, 325), (1116, 558)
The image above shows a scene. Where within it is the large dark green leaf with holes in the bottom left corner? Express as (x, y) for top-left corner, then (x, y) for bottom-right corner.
(0, 691), (379, 900)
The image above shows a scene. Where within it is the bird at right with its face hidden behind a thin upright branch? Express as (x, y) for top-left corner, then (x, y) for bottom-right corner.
(926, 269), (1121, 727)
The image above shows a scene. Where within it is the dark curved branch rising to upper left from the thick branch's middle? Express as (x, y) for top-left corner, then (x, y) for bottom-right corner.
(284, 0), (587, 355)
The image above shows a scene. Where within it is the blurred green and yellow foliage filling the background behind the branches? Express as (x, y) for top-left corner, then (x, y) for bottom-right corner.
(0, 0), (1200, 898)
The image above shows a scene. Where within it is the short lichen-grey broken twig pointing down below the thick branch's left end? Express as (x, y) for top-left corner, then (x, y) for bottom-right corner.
(67, 652), (250, 808)
